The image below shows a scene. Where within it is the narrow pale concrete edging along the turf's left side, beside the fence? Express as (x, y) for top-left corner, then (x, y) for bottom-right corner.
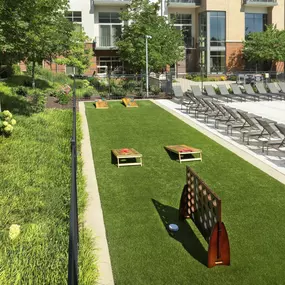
(79, 102), (114, 285)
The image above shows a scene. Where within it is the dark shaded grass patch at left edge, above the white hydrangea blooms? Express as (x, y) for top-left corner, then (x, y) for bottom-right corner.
(0, 93), (32, 116)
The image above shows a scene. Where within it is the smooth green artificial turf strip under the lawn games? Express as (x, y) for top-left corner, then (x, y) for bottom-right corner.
(85, 101), (285, 285)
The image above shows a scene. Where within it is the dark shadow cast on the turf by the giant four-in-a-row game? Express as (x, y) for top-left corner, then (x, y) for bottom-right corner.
(152, 199), (208, 266)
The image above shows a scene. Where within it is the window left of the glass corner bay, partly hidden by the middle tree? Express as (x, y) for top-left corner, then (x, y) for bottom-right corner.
(170, 14), (194, 48)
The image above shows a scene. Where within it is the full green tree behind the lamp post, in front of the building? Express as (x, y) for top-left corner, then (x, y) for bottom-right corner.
(116, 0), (184, 72)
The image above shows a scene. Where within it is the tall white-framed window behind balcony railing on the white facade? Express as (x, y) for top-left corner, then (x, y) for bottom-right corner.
(99, 12), (122, 47)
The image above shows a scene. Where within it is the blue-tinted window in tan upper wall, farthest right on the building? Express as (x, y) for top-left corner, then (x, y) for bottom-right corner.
(245, 13), (267, 36)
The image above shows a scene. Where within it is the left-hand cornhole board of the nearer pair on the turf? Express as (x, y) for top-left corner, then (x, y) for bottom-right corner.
(112, 148), (142, 167)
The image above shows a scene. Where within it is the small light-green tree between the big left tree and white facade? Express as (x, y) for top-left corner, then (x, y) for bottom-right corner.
(55, 31), (92, 75)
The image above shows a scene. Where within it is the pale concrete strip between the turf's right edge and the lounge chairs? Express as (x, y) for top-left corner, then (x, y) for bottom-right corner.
(153, 100), (285, 184)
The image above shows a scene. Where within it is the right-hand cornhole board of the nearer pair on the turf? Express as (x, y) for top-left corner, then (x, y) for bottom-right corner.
(165, 144), (202, 163)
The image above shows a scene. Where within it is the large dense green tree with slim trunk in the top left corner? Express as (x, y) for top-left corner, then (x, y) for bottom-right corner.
(0, 0), (73, 86)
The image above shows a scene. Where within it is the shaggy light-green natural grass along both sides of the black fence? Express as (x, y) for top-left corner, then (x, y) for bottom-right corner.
(0, 107), (97, 285)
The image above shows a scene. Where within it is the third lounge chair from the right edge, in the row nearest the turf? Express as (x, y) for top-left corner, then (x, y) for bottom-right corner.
(237, 110), (267, 144)
